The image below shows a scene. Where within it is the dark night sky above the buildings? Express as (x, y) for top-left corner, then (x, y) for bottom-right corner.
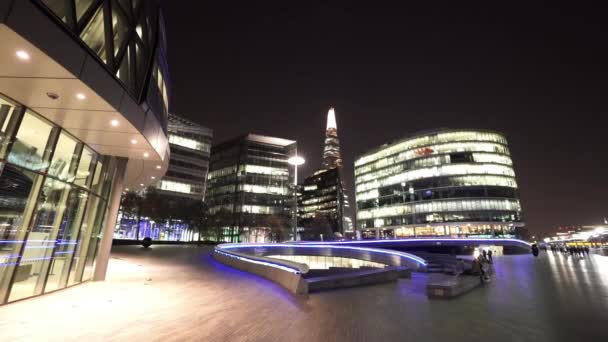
(164, 0), (608, 238)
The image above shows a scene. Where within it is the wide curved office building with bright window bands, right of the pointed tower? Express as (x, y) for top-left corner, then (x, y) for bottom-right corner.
(355, 130), (524, 238)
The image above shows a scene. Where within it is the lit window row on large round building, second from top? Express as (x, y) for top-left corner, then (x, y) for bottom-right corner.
(355, 142), (510, 175)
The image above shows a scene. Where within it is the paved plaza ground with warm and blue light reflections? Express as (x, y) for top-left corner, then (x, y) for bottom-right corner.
(0, 246), (608, 342)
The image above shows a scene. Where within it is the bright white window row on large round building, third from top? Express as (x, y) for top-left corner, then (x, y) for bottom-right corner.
(356, 164), (515, 193)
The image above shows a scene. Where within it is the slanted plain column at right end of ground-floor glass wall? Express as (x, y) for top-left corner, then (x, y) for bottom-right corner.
(93, 158), (129, 281)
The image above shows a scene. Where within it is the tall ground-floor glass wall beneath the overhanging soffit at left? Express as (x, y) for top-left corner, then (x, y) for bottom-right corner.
(0, 96), (115, 304)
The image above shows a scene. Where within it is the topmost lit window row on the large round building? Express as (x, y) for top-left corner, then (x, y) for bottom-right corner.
(355, 131), (507, 167)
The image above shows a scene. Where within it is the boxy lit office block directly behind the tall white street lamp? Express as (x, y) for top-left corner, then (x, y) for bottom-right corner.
(205, 134), (297, 242)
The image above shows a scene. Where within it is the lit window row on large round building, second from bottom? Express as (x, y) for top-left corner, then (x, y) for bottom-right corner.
(357, 199), (521, 220)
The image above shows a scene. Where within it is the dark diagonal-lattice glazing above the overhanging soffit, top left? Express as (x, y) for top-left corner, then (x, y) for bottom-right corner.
(36, 0), (169, 128)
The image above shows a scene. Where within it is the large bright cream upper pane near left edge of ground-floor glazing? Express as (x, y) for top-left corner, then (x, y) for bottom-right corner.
(8, 112), (53, 171)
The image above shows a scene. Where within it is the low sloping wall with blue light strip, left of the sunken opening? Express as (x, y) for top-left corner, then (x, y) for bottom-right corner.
(213, 247), (308, 294)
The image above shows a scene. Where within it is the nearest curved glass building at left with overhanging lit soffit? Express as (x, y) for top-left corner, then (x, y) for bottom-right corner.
(0, 0), (169, 305)
